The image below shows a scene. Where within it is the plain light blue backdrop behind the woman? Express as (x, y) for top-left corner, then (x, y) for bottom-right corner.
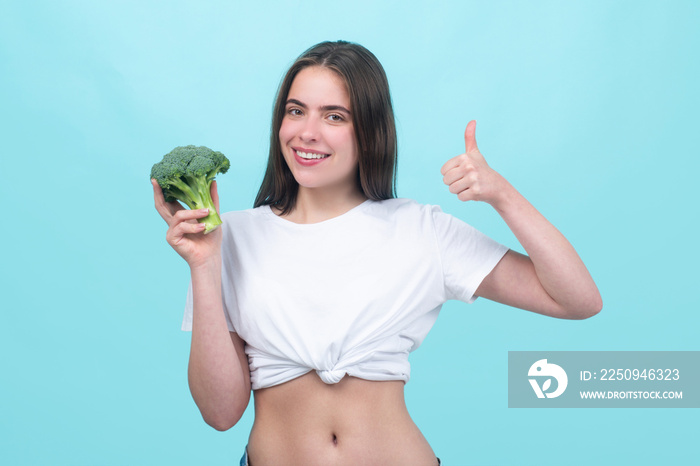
(0, 0), (700, 465)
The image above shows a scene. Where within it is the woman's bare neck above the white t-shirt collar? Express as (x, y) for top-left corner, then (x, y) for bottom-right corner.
(273, 186), (367, 223)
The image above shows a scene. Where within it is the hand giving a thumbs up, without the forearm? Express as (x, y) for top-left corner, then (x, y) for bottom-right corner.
(440, 120), (510, 207)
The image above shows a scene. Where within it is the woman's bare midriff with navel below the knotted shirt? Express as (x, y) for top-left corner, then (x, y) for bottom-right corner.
(248, 371), (438, 466)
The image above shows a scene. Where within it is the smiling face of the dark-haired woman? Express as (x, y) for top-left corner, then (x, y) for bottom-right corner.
(279, 66), (360, 192)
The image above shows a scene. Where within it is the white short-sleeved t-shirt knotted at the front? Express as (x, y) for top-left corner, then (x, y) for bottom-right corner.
(182, 199), (507, 390)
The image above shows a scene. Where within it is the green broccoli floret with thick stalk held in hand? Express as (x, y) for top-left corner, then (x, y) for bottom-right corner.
(151, 146), (231, 234)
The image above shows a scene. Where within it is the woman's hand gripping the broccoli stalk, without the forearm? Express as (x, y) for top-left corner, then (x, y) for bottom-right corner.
(151, 179), (221, 268)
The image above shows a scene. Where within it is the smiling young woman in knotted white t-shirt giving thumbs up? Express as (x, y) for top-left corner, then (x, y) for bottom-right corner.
(153, 41), (602, 466)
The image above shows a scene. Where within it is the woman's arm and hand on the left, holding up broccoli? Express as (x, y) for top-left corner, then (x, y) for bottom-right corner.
(152, 180), (250, 430)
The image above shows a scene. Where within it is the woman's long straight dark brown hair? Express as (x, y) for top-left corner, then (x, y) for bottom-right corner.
(254, 41), (397, 214)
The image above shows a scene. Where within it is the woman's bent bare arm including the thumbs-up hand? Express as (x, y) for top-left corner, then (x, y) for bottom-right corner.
(441, 120), (603, 319)
